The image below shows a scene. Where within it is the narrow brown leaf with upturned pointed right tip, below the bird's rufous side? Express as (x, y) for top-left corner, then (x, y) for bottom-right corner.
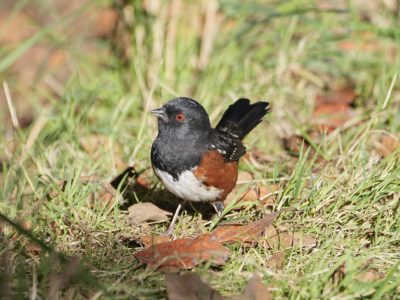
(211, 211), (281, 244)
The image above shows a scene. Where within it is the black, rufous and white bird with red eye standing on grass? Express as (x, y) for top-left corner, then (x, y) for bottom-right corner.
(150, 97), (270, 235)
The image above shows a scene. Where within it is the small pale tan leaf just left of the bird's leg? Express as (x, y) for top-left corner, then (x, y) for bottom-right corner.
(128, 202), (172, 225)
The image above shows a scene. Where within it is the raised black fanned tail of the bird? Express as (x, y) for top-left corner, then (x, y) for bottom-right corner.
(216, 98), (270, 139)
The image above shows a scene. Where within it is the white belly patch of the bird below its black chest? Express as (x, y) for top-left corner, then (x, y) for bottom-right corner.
(155, 169), (221, 202)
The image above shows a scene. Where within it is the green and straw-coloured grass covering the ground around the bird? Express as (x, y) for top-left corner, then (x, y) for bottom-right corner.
(0, 0), (400, 299)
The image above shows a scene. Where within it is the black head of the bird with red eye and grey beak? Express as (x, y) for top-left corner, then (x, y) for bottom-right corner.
(151, 97), (211, 138)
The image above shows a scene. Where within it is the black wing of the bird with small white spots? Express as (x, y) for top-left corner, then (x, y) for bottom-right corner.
(208, 130), (246, 162)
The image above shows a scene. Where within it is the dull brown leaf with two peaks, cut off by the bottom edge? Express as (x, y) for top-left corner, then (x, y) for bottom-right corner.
(165, 273), (272, 300)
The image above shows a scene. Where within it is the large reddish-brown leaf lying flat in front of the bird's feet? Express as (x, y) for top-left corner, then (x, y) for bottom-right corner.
(135, 234), (229, 271)
